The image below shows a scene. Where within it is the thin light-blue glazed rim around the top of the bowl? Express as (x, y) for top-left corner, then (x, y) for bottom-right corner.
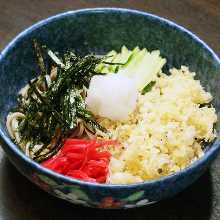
(0, 7), (220, 189)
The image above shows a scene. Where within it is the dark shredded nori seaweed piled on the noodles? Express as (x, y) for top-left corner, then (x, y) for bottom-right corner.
(17, 40), (110, 161)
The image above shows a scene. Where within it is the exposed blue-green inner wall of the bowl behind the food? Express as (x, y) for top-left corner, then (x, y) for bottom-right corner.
(0, 9), (220, 150)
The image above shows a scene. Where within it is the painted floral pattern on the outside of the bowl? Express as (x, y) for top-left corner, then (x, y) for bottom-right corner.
(32, 174), (155, 209)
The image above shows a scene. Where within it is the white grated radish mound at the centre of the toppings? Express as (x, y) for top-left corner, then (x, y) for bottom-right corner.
(86, 73), (138, 121)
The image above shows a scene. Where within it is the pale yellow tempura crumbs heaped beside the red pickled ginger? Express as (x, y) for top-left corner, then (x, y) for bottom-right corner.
(99, 66), (217, 184)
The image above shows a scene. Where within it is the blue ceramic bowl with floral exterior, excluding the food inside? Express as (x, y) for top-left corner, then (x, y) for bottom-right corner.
(0, 8), (220, 208)
